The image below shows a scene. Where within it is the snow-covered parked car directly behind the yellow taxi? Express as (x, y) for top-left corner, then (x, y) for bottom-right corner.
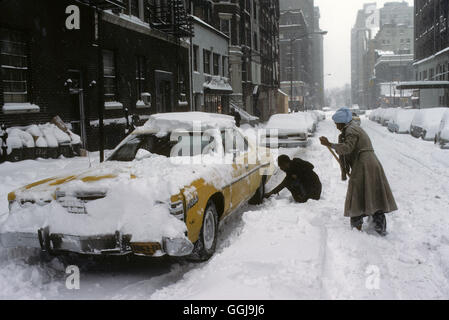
(260, 113), (309, 148)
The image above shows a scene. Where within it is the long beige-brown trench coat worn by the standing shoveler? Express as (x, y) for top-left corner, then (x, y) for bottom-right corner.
(332, 122), (398, 217)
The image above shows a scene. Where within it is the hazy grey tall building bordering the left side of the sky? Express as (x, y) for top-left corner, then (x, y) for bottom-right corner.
(280, 0), (324, 110)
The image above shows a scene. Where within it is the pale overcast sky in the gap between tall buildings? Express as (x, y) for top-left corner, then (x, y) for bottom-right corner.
(314, 0), (413, 88)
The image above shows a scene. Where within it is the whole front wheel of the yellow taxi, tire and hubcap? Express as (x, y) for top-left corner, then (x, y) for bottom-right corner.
(189, 200), (218, 261)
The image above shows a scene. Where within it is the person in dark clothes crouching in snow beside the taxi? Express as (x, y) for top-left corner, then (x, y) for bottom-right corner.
(265, 155), (321, 203)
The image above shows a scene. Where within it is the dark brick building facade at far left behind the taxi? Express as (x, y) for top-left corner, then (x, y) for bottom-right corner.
(0, 0), (190, 150)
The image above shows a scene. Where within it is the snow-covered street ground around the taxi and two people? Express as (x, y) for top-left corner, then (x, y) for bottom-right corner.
(0, 115), (449, 300)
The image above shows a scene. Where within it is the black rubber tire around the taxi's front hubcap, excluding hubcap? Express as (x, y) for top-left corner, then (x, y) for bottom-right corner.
(188, 200), (218, 262)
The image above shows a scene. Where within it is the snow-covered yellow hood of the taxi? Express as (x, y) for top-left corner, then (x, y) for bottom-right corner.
(9, 155), (234, 208)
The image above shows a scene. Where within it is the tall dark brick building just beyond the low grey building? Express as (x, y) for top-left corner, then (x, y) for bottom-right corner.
(192, 0), (279, 119)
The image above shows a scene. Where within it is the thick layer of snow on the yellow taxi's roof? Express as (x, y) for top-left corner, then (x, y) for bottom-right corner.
(143, 112), (235, 132)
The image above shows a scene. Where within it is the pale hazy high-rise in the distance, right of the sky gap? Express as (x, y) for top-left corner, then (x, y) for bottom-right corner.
(351, 1), (414, 108)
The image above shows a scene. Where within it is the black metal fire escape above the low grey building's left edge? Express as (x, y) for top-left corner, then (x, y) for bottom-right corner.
(149, 0), (193, 39)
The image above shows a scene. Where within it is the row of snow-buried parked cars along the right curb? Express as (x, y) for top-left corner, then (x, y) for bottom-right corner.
(369, 108), (449, 148)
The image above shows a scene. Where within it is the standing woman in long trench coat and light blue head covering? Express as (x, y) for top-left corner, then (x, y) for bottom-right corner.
(320, 108), (398, 236)
